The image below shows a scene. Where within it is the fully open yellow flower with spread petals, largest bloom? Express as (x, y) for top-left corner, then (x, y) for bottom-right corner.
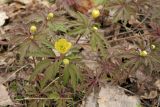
(54, 39), (72, 54)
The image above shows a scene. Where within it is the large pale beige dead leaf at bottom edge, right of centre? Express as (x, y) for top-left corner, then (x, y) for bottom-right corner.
(84, 85), (140, 107)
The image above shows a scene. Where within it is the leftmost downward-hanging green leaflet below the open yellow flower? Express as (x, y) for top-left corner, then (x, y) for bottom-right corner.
(30, 59), (51, 80)
